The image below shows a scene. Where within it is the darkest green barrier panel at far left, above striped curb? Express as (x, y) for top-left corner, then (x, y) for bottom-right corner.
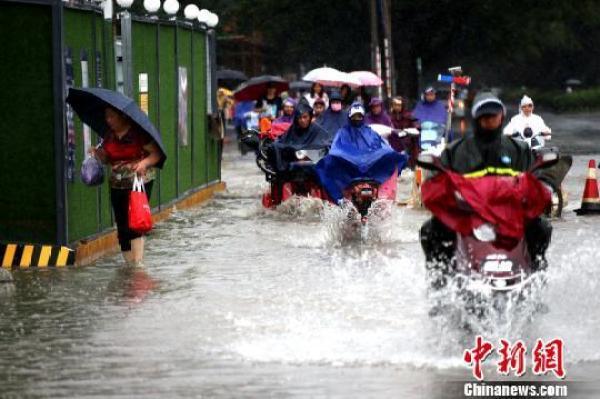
(0, 2), (57, 242)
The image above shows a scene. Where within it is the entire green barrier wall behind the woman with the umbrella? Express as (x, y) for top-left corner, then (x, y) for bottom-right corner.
(0, 2), (219, 247)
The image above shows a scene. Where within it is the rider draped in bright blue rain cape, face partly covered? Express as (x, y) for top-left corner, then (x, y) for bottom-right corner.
(316, 103), (407, 203)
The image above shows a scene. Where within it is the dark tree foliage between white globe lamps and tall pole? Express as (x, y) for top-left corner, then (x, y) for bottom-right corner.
(192, 0), (370, 73)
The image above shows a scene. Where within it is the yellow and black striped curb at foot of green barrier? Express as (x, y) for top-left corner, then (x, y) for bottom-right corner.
(0, 243), (75, 269)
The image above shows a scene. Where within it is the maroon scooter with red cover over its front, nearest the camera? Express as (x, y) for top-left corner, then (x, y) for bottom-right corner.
(417, 152), (559, 292)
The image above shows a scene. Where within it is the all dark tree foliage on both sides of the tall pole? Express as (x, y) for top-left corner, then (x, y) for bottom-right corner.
(184, 0), (600, 92)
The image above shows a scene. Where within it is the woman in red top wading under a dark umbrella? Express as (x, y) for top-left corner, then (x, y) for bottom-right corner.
(67, 89), (166, 265)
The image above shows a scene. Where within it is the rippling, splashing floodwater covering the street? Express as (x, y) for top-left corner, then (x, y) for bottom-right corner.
(0, 113), (600, 398)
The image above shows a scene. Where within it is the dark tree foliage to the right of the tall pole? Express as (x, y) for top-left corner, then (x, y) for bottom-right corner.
(393, 0), (600, 87)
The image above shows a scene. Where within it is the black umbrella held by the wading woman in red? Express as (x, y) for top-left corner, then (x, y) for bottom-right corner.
(67, 88), (167, 168)
